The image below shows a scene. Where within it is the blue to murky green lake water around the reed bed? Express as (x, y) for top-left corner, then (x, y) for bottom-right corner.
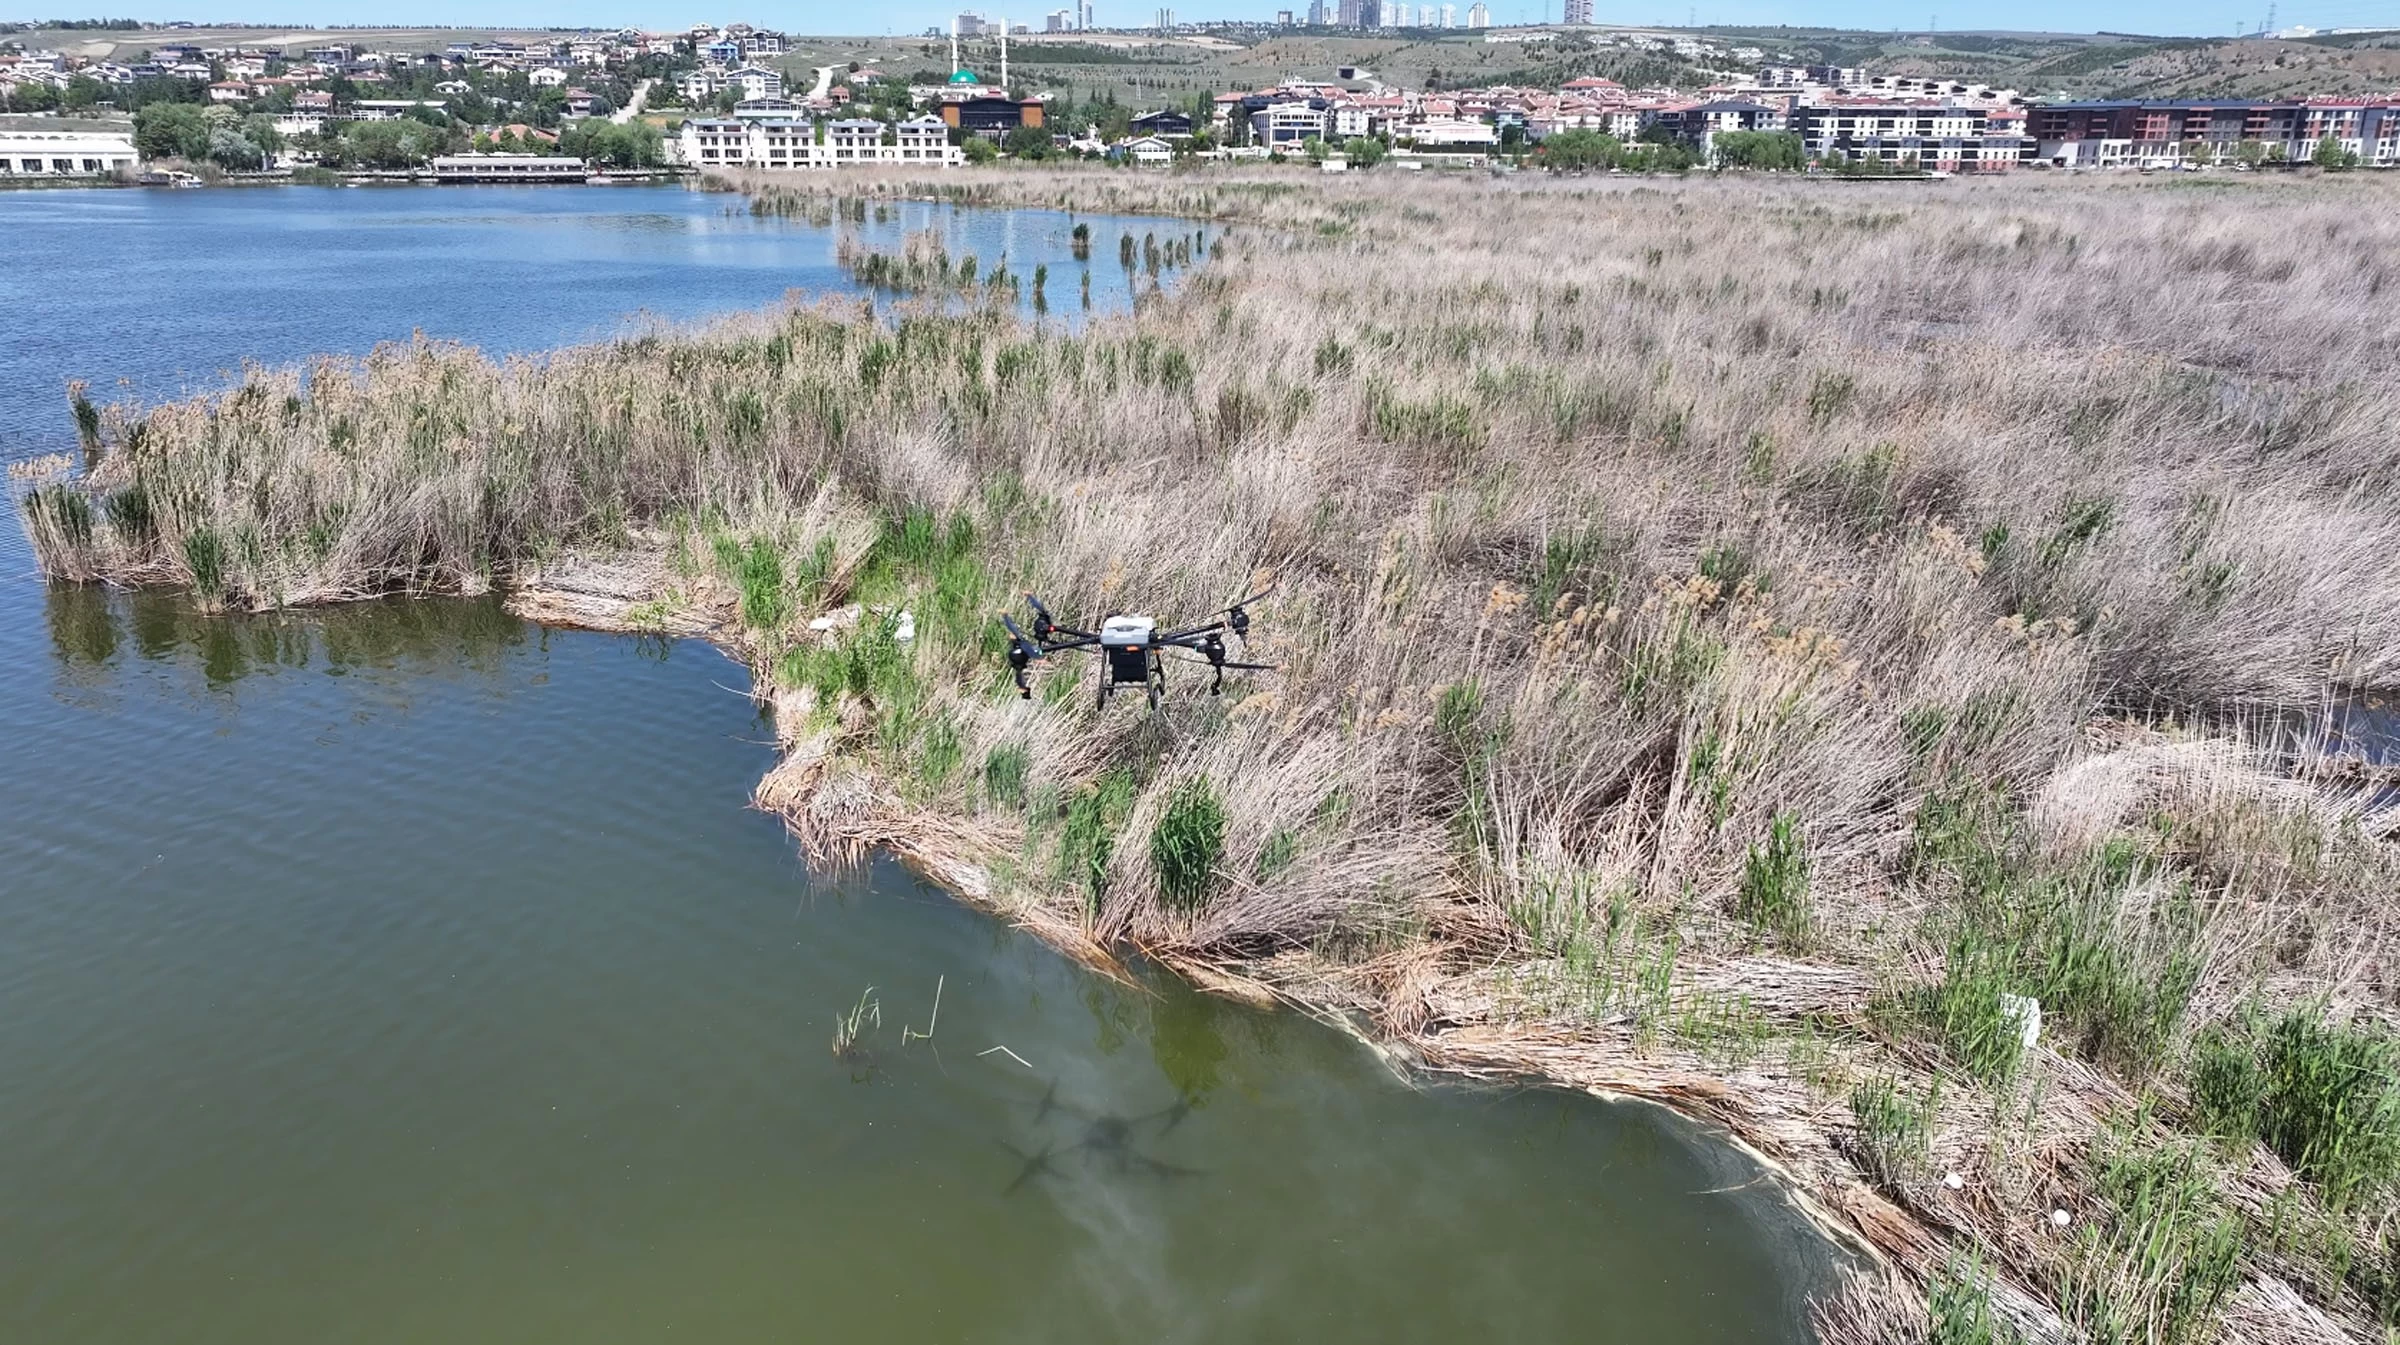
(0, 187), (1824, 1345)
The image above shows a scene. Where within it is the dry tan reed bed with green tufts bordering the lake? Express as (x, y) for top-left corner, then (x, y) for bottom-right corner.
(26, 171), (2400, 1340)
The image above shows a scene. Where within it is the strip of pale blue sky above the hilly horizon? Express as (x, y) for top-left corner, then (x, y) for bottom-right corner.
(65, 0), (2400, 34)
